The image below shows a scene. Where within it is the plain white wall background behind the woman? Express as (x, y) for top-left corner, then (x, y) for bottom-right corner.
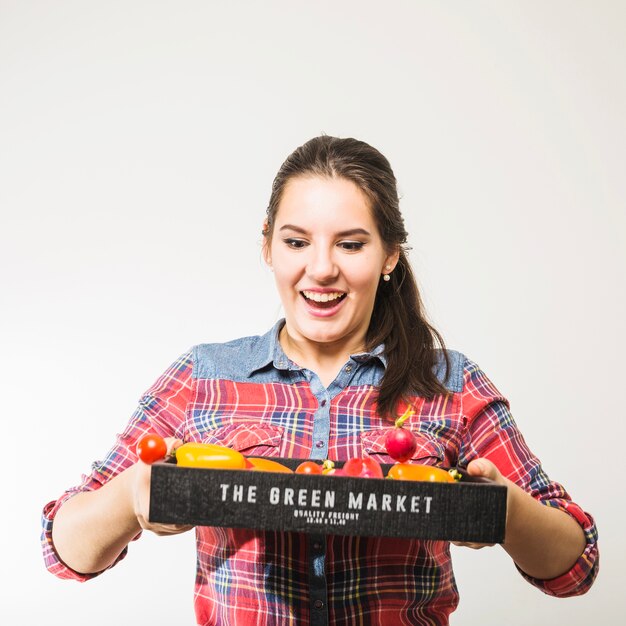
(0, 0), (626, 626)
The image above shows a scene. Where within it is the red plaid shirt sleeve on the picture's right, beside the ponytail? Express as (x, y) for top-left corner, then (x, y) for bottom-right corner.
(459, 360), (599, 597)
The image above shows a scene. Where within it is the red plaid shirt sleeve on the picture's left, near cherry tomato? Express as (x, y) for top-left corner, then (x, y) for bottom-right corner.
(41, 352), (193, 581)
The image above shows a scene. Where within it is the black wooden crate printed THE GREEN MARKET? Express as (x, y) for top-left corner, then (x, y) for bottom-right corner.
(150, 459), (506, 543)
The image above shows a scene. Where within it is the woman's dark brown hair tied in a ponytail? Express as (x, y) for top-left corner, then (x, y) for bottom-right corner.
(263, 135), (449, 418)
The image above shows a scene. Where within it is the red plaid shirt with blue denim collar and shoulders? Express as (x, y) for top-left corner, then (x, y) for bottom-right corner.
(42, 322), (598, 626)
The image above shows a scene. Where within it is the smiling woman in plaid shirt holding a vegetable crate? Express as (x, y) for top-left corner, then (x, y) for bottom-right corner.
(43, 136), (598, 625)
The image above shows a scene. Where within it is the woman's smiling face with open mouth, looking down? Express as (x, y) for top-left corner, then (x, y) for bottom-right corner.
(265, 176), (398, 353)
